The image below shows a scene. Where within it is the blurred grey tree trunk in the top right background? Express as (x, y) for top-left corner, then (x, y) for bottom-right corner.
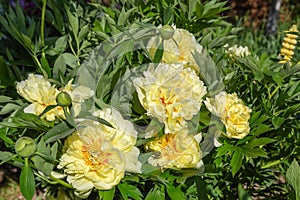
(265, 0), (282, 34)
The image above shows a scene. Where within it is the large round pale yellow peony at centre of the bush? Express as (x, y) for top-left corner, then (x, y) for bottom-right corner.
(133, 63), (206, 133)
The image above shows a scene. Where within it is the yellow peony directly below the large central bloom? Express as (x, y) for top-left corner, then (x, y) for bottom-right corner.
(145, 129), (202, 169)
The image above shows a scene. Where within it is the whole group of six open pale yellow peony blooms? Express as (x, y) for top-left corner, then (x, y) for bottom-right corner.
(17, 25), (251, 198)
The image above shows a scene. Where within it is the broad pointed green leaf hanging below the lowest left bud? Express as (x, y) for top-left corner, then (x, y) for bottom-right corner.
(20, 158), (35, 200)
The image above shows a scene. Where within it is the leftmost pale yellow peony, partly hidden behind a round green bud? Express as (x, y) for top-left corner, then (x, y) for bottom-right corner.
(16, 74), (94, 121)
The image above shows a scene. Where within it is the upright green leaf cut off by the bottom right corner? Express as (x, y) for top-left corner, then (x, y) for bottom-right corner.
(286, 159), (300, 199)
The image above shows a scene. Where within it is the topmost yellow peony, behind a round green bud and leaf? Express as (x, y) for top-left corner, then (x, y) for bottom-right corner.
(147, 26), (203, 73)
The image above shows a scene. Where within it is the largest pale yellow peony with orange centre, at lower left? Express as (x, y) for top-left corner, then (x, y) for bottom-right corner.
(58, 109), (141, 198)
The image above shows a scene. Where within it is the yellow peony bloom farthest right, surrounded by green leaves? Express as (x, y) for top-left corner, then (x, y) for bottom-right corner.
(204, 92), (251, 139)
